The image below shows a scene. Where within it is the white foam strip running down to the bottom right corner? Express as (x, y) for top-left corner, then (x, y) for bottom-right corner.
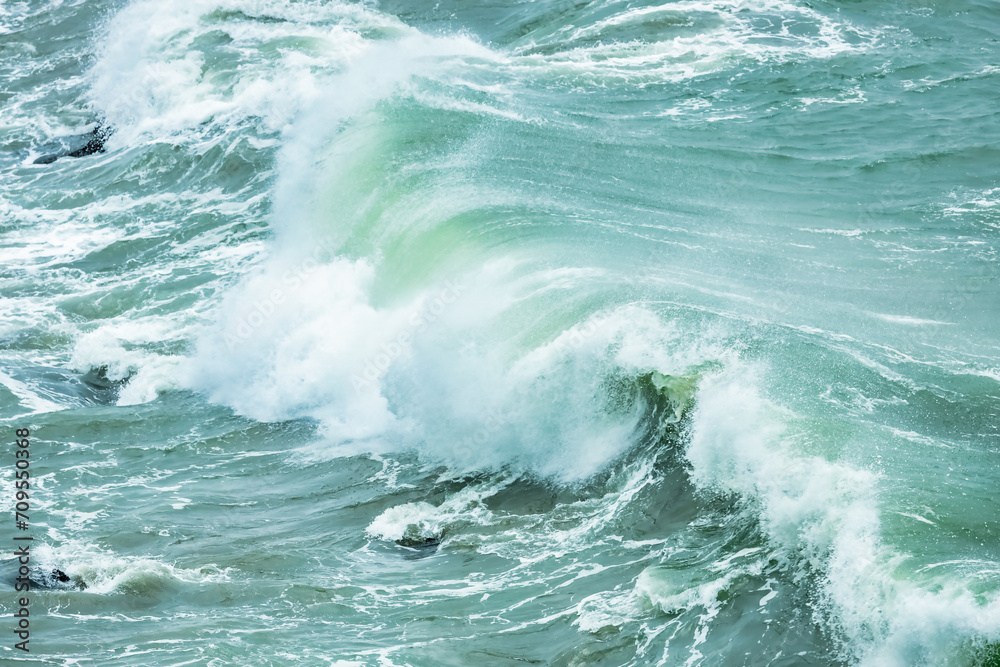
(688, 372), (1000, 666)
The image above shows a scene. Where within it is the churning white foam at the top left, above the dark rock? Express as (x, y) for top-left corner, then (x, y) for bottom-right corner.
(91, 0), (407, 146)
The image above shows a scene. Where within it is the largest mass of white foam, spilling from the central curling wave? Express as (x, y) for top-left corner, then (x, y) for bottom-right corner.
(185, 32), (704, 479)
